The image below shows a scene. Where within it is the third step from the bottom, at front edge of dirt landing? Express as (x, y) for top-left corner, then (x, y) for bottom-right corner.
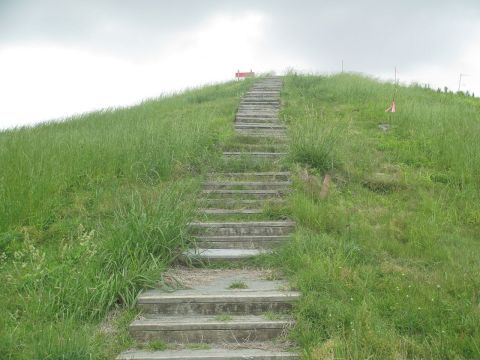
(138, 286), (300, 317)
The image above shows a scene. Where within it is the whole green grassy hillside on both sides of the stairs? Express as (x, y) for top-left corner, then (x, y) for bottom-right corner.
(0, 74), (480, 359)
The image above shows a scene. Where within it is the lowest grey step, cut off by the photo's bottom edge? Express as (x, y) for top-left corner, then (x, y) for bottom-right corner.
(116, 348), (299, 360)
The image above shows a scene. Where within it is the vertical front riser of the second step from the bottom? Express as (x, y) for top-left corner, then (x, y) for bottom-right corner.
(130, 328), (286, 344)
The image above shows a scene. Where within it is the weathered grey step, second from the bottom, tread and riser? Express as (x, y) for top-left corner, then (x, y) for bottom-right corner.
(129, 315), (293, 343)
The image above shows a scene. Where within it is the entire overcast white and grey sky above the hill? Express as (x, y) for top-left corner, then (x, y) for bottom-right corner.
(0, 0), (480, 128)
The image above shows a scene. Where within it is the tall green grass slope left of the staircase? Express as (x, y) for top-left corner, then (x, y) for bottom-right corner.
(0, 81), (251, 359)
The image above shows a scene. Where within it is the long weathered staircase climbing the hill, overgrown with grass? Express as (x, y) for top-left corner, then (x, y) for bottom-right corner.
(117, 77), (299, 360)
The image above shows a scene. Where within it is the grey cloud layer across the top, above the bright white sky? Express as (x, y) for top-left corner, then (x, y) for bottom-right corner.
(0, 0), (480, 71)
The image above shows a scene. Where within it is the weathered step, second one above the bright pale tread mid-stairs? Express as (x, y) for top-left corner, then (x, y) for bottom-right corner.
(189, 220), (295, 236)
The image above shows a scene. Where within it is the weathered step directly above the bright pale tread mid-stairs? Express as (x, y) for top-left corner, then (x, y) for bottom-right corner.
(195, 235), (290, 249)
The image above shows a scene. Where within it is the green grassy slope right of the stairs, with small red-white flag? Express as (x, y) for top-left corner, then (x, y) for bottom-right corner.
(279, 74), (480, 359)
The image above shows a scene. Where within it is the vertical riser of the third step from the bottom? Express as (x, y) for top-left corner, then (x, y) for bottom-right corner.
(138, 300), (292, 315)
